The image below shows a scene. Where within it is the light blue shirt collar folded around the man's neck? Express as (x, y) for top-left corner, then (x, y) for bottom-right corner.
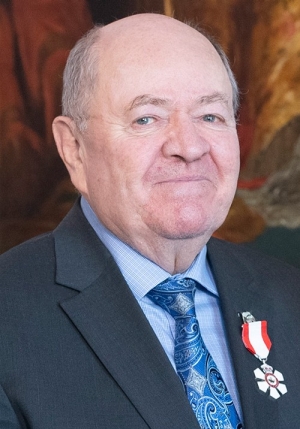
(81, 197), (218, 299)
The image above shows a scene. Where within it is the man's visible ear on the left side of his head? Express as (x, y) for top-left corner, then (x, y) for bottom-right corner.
(52, 116), (86, 194)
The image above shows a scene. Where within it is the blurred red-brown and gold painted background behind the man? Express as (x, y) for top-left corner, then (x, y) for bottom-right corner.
(0, 0), (300, 268)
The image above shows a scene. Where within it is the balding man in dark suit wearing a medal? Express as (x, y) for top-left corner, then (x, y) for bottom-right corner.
(0, 14), (300, 429)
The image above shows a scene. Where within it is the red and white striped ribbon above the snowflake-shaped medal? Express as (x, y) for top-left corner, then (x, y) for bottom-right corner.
(242, 320), (272, 361)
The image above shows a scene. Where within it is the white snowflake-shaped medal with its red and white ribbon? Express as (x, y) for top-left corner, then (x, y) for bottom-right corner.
(241, 311), (287, 399)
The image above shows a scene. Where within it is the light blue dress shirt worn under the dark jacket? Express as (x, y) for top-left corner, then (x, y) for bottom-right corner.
(81, 197), (241, 417)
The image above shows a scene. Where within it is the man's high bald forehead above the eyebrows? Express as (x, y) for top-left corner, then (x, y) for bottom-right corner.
(92, 17), (231, 108)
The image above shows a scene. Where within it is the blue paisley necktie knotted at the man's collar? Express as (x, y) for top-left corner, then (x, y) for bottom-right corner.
(147, 278), (242, 429)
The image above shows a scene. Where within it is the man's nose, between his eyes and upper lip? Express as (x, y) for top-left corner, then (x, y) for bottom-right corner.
(163, 117), (210, 163)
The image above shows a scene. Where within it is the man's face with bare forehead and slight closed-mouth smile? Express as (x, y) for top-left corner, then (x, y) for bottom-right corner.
(79, 15), (239, 250)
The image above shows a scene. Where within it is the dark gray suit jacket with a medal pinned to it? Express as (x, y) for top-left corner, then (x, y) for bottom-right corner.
(0, 201), (300, 429)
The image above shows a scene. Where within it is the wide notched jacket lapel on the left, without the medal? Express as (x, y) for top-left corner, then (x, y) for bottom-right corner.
(55, 203), (199, 429)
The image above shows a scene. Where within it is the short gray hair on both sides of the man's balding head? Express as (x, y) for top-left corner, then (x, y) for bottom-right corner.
(62, 19), (239, 132)
